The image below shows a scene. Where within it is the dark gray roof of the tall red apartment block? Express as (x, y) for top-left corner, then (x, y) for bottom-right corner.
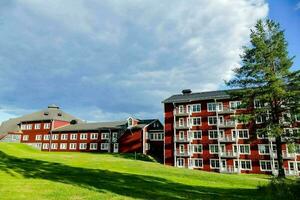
(162, 89), (236, 103)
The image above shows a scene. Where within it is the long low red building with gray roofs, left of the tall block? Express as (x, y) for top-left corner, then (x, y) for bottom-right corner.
(0, 105), (164, 161)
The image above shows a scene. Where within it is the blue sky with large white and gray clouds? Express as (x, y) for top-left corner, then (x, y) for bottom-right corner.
(0, 0), (300, 121)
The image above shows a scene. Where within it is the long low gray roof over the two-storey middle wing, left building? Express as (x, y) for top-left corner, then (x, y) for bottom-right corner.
(53, 121), (127, 132)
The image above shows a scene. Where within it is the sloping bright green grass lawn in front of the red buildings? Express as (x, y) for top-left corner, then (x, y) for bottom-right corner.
(0, 143), (270, 200)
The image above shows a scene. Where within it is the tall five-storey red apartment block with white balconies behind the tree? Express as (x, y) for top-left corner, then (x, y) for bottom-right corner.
(163, 90), (300, 175)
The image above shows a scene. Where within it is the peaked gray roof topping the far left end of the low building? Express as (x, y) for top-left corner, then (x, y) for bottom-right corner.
(20, 104), (82, 122)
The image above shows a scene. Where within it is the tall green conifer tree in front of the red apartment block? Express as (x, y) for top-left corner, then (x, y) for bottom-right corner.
(226, 19), (300, 178)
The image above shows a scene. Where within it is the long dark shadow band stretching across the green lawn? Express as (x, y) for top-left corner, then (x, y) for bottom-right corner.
(0, 151), (259, 199)
